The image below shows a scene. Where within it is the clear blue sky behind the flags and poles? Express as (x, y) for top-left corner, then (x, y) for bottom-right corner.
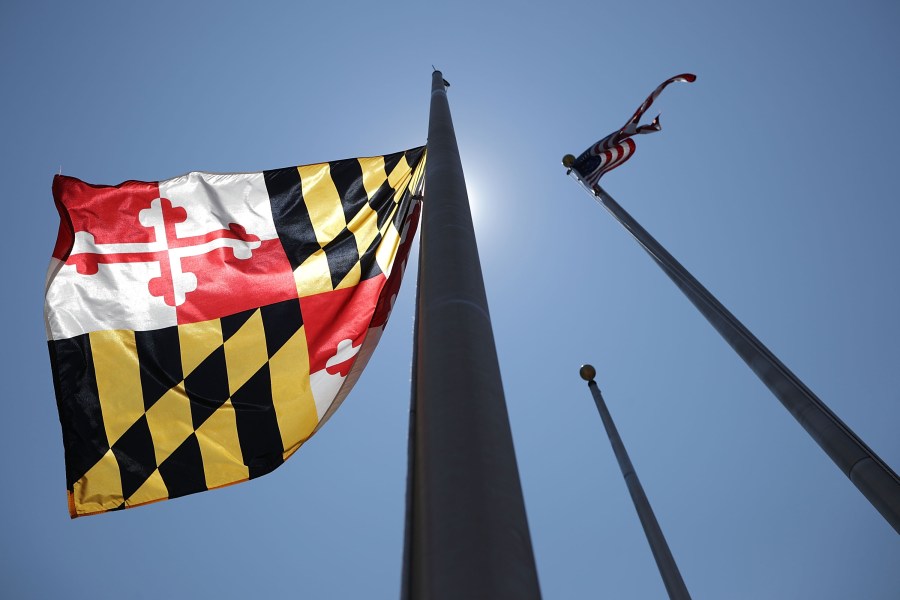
(0, 0), (900, 600)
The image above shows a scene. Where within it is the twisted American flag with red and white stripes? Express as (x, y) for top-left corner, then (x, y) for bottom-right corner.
(566, 73), (697, 188)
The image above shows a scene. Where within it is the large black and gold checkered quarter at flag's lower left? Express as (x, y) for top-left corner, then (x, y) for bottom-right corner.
(51, 300), (318, 516)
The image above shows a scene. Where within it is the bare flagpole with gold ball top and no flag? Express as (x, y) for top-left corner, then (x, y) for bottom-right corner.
(578, 365), (691, 600)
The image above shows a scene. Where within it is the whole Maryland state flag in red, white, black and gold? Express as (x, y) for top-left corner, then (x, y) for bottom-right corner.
(44, 147), (425, 518)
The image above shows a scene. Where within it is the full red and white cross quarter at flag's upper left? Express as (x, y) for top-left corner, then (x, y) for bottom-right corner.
(47, 173), (297, 339)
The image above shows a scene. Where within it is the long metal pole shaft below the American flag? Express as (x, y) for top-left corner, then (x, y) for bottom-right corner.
(594, 186), (900, 533)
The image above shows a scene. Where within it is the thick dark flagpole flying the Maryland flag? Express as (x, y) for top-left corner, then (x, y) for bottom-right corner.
(402, 70), (540, 600)
